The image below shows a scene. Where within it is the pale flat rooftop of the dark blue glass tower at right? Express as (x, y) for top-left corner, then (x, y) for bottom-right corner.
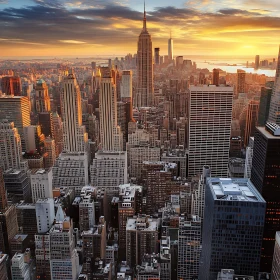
(207, 178), (265, 203)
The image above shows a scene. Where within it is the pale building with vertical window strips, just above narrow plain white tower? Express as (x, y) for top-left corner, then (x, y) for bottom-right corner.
(30, 168), (53, 203)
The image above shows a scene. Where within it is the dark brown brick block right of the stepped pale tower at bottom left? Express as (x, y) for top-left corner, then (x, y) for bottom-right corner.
(81, 216), (106, 277)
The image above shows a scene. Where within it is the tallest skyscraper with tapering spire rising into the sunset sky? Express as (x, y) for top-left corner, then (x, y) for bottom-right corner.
(135, 4), (154, 107)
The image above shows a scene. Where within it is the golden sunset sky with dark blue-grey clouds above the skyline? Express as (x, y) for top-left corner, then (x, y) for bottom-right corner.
(0, 0), (280, 59)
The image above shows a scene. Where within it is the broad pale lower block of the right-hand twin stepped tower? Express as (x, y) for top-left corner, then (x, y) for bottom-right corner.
(90, 151), (128, 195)
